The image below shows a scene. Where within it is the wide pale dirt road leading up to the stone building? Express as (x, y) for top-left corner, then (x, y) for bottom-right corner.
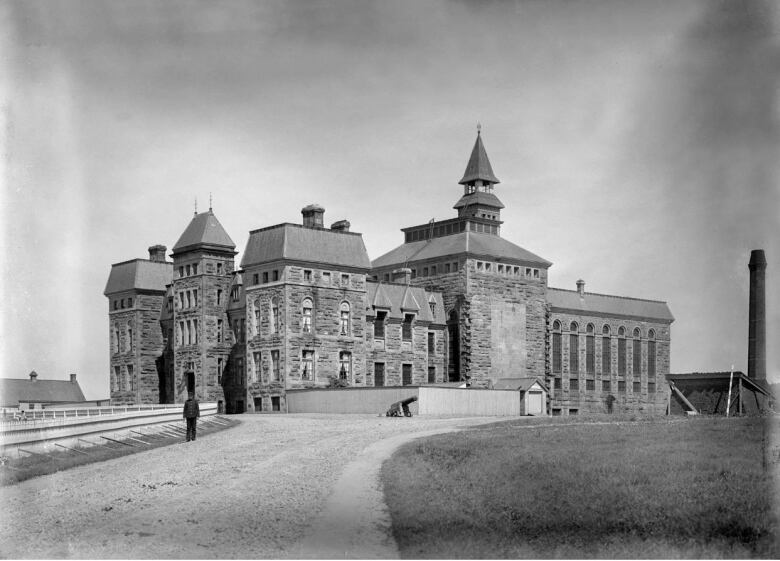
(0, 415), (496, 559)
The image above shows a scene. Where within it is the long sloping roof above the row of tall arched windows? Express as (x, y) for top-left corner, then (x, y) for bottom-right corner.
(547, 288), (674, 323)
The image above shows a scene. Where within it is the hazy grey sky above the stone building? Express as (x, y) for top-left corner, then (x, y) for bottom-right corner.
(0, 0), (780, 399)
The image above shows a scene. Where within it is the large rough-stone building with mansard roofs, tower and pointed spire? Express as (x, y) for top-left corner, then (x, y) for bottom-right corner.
(105, 129), (673, 414)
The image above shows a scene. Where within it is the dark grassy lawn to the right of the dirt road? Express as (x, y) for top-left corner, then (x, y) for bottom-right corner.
(382, 418), (780, 559)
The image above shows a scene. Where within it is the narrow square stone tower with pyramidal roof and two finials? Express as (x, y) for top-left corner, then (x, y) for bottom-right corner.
(173, 208), (237, 403)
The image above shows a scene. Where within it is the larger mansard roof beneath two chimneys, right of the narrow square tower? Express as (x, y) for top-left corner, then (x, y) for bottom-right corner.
(241, 224), (371, 270)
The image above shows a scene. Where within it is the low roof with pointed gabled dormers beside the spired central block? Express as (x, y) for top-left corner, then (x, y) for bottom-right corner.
(366, 281), (447, 324)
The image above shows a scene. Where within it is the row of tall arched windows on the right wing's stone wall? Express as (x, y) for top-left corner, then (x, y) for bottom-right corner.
(552, 320), (656, 378)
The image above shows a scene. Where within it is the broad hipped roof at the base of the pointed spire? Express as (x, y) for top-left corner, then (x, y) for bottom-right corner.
(372, 230), (552, 268)
